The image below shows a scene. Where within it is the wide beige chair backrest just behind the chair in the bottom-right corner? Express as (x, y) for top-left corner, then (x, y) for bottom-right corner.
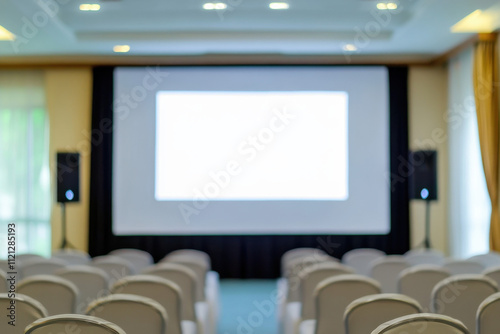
(432, 275), (498, 333)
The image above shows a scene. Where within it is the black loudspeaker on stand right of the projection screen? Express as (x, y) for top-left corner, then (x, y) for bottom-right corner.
(409, 150), (437, 200)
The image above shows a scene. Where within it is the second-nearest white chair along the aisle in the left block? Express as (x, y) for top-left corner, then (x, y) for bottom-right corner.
(142, 262), (209, 334)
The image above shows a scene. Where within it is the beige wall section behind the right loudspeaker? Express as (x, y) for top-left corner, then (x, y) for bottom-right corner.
(408, 66), (449, 254)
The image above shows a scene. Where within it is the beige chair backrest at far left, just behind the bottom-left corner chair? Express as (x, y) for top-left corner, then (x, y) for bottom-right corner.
(17, 275), (78, 315)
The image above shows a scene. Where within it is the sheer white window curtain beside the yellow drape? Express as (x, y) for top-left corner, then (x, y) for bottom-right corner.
(447, 48), (491, 258)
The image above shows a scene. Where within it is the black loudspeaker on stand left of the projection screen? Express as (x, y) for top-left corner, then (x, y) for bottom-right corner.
(56, 153), (80, 203)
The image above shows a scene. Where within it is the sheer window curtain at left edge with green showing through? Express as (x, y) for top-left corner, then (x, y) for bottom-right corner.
(0, 70), (51, 258)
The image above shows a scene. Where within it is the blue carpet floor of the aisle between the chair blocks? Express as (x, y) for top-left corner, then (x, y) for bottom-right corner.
(217, 280), (278, 334)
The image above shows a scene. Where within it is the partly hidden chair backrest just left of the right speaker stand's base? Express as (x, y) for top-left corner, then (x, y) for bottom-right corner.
(370, 255), (410, 293)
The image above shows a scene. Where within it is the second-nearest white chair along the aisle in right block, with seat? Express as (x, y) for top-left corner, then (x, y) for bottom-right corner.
(284, 262), (354, 334)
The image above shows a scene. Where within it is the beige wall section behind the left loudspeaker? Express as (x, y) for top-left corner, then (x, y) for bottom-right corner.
(45, 67), (92, 251)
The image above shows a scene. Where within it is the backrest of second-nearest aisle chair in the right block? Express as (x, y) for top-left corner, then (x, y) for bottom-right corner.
(299, 262), (354, 320)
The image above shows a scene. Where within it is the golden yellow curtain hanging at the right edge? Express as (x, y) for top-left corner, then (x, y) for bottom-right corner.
(473, 33), (500, 251)
